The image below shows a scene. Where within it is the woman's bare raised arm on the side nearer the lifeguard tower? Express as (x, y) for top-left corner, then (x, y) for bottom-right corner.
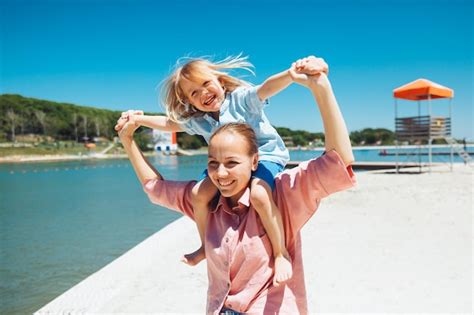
(289, 58), (354, 165)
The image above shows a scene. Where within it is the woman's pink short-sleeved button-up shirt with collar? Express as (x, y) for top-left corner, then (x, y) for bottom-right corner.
(144, 151), (355, 314)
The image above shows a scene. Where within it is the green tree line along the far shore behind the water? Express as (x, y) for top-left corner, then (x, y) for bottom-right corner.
(0, 94), (395, 149)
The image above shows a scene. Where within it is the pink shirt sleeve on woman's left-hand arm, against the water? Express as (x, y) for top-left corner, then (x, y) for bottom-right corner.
(143, 179), (196, 220)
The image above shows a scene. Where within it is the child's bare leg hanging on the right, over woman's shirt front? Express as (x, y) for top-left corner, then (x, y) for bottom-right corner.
(250, 178), (293, 286)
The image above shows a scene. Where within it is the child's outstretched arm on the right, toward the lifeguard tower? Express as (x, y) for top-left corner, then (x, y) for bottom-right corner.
(257, 56), (328, 101)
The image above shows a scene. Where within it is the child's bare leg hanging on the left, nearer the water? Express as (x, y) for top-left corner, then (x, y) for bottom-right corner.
(182, 177), (217, 266)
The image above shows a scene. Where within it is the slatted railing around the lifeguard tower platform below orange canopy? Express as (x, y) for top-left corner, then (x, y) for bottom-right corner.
(395, 116), (451, 141)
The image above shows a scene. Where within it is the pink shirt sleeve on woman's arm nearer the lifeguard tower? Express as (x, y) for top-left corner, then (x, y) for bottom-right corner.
(275, 150), (356, 240)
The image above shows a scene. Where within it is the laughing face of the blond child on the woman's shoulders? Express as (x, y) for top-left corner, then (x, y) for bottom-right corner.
(179, 77), (225, 112)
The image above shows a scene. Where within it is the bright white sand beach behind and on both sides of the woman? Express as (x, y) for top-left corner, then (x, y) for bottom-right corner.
(38, 165), (473, 314)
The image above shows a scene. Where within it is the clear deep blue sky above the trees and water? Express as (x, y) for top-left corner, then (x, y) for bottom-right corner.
(0, 0), (474, 140)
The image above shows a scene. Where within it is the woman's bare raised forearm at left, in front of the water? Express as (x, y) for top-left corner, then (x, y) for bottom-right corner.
(119, 118), (163, 185)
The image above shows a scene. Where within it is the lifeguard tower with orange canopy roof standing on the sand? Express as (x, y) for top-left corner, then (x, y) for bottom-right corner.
(393, 79), (470, 172)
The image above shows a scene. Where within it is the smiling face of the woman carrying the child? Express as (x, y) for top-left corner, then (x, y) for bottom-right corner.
(207, 132), (258, 206)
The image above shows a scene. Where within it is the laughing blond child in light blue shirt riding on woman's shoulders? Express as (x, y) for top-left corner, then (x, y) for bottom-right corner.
(115, 55), (327, 285)
